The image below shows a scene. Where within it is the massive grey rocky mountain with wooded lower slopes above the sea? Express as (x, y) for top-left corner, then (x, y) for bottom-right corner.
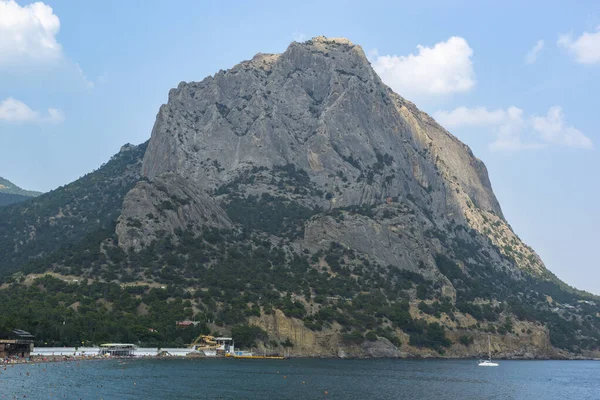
(0, 37), (600, 358)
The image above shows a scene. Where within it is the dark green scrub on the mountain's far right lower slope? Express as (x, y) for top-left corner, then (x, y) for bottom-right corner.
(436, 240), (600, 353)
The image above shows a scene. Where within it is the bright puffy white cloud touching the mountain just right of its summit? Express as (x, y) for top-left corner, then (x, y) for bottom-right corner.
(371, 36), (475, 98)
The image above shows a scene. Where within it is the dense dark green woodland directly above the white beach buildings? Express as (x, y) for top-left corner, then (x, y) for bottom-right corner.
(0, 276), (208, 346)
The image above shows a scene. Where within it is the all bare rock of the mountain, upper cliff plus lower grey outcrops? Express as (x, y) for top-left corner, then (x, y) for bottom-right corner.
(117, 37), (544, 273)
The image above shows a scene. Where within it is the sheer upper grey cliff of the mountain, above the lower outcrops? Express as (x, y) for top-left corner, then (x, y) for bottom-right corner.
(143, 38), (501, 215)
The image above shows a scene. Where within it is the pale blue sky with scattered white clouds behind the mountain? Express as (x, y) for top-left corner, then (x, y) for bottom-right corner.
(0, 0), (600, 294)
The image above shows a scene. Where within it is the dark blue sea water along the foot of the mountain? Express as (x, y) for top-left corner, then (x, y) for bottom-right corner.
(0, 359), (600, 400)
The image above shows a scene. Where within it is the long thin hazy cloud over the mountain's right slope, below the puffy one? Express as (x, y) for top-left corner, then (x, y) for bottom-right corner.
(434, 106), (594, 151)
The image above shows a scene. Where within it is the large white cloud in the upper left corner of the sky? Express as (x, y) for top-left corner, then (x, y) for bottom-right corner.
(0, 0), (62, 66)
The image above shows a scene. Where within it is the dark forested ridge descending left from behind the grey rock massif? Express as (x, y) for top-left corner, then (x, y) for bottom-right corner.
(0, 144), (146, 274)
